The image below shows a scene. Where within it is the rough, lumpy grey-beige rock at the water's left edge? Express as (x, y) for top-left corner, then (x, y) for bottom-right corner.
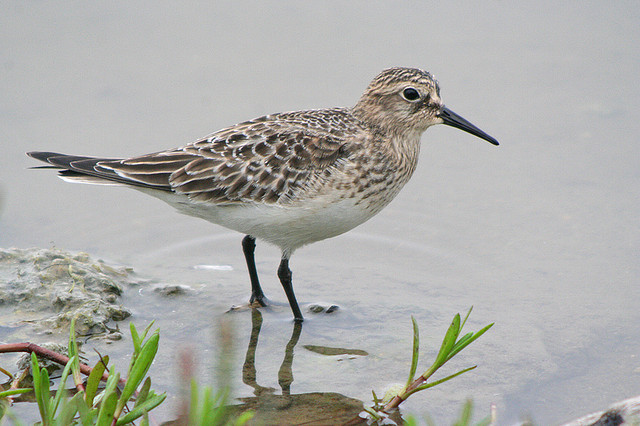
(0, 248), (133, 336)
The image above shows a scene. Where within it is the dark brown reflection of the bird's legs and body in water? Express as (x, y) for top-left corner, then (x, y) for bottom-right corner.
(229, 309), (390, 425)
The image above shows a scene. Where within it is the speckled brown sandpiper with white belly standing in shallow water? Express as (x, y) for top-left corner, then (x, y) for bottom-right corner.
(27, 67), (498, 322)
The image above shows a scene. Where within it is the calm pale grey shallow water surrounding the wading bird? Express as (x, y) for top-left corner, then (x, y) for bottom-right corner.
(0, 2), (640, 424)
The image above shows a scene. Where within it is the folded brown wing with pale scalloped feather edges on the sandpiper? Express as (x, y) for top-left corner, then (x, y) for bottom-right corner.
(96, 111), (359, 204)
